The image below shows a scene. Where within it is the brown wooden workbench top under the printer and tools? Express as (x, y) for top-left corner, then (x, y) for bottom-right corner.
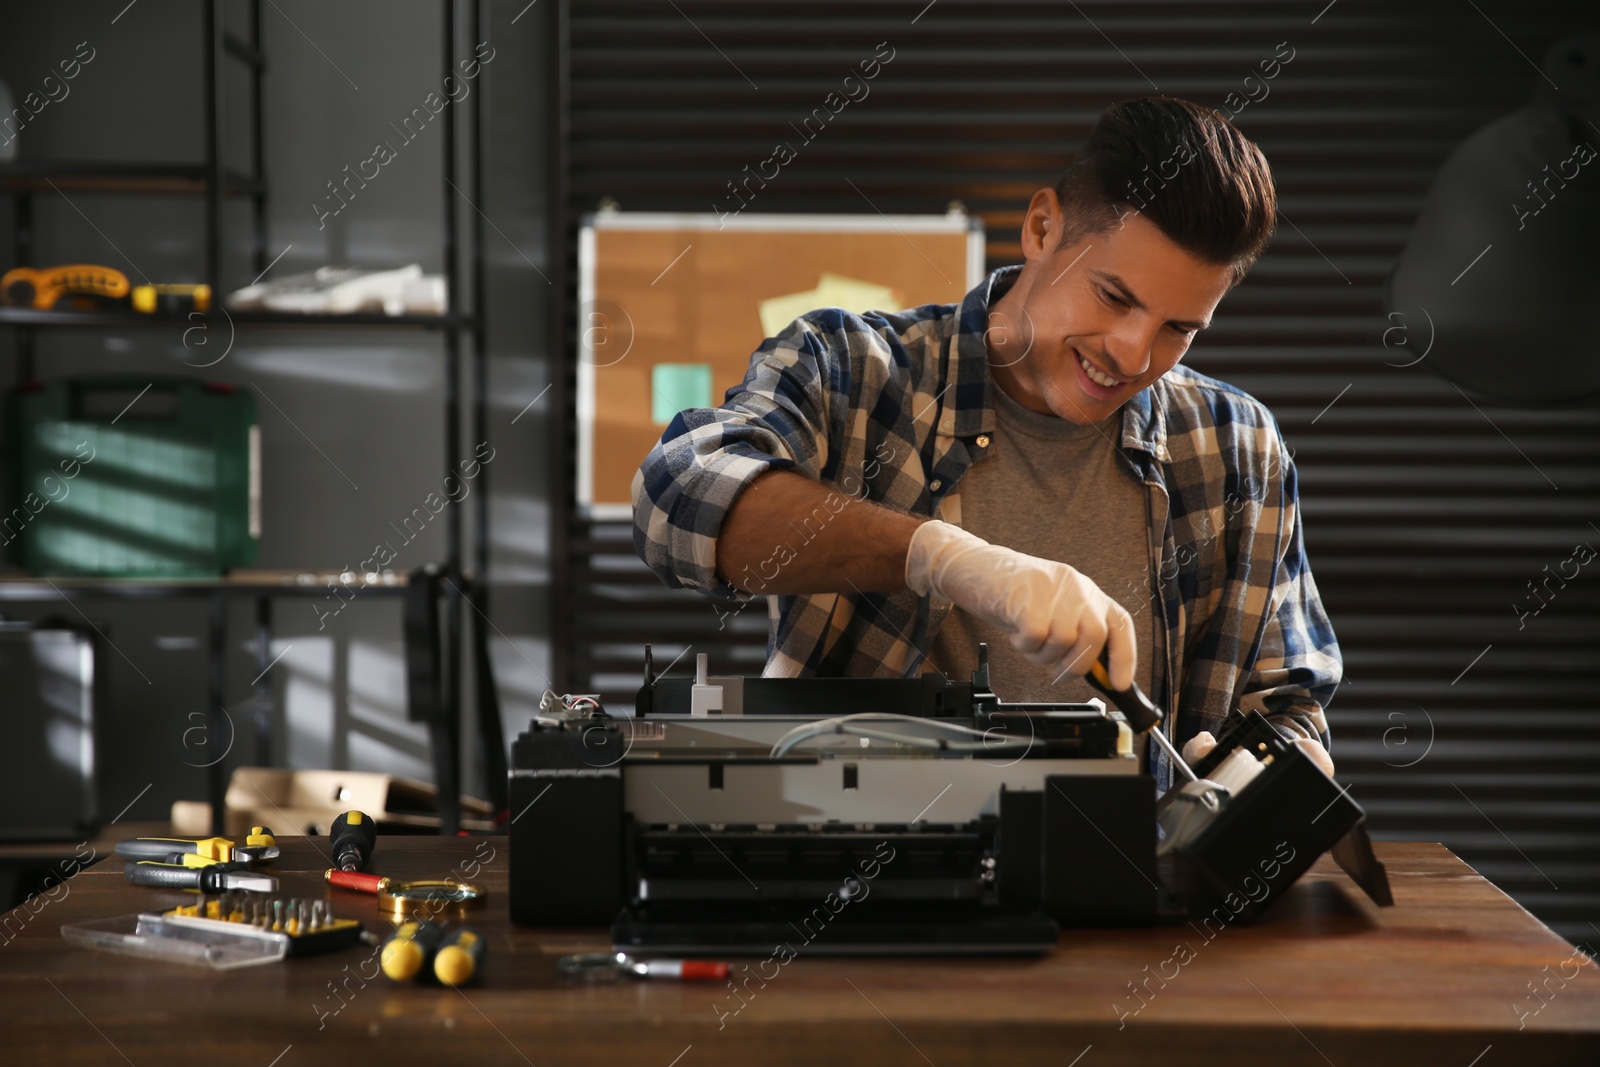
(0, 837), (1600, 1067)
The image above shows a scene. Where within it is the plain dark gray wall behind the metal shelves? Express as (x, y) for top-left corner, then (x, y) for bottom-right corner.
(0, 0), (549, 817)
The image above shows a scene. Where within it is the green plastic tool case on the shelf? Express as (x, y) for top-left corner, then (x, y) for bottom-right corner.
(0, 378), (261, 577)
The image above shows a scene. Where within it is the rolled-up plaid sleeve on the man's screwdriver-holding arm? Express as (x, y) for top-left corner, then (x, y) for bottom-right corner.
(632, 318), (848, 598)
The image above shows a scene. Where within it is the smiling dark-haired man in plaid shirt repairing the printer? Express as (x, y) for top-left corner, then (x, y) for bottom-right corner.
(634, 98), (1341, 790)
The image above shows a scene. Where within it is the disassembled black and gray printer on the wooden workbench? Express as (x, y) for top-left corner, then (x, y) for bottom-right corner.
(510, 645), (1390, 955)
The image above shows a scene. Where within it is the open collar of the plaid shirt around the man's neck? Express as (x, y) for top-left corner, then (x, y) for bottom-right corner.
(938, 264), (1166, 459)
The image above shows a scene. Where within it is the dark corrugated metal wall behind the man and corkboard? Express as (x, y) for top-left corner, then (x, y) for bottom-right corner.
(555, 0), (1600, 939)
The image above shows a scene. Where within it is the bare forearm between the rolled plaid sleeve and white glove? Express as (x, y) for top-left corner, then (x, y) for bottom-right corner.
(717, 470), (928, 593)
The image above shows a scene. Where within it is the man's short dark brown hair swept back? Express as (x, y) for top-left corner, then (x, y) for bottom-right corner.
(1056, 96), (1277, 285)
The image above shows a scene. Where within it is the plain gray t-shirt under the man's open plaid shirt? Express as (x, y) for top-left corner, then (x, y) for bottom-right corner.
(923, 375), (1155, 765)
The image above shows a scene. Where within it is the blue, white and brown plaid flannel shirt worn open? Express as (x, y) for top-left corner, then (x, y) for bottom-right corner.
(632, 267), (1342, 790)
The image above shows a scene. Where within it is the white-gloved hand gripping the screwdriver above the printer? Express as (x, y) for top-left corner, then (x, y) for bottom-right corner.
(906, 520), (1138, 689)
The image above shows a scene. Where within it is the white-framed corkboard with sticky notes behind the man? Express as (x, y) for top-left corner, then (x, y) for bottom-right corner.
(574, 211), (982, 518)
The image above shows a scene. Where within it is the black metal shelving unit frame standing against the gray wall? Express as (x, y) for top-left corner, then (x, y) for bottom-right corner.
(0, 0), (506, 833)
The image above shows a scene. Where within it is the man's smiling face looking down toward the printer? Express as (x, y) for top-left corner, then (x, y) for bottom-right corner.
(986, 189), (1234, 426)
